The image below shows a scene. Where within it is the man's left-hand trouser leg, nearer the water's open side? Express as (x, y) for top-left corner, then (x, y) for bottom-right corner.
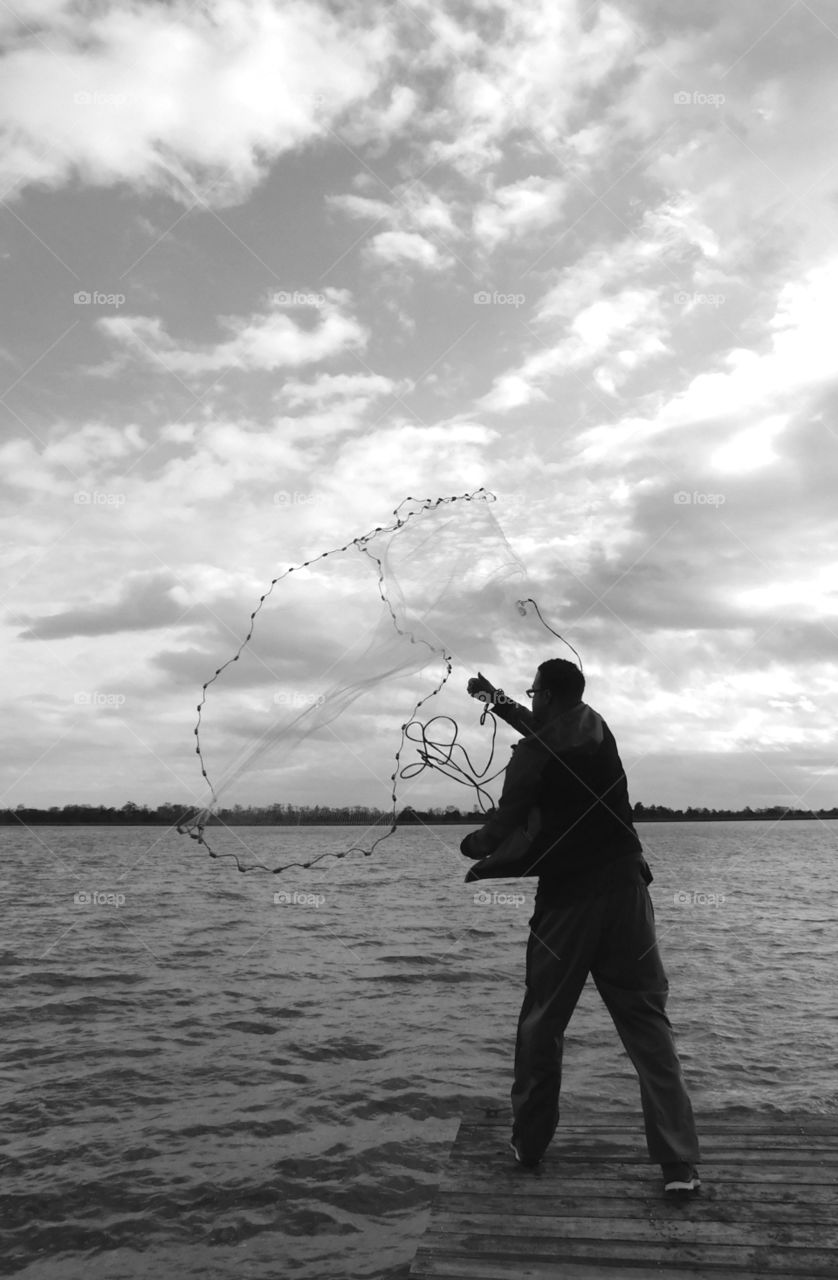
(512, 901), (599, 1164)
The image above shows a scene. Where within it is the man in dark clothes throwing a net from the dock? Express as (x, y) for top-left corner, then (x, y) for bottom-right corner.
(461, 658), (700, 1192)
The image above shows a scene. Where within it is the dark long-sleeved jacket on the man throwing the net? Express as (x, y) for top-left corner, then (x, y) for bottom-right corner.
(461, 700), (652, 902)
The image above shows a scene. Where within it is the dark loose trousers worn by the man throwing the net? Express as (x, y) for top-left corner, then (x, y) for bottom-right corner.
(512, 876), (699, 1165)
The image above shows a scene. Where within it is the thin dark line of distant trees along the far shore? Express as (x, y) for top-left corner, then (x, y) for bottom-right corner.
(0, 800), (838, 827)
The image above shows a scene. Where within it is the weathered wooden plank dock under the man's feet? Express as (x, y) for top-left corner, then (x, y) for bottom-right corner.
(409, 1108), (838, 1280)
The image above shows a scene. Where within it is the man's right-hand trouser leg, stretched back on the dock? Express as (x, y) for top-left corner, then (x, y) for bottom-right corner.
(591, 879), (700, 1165)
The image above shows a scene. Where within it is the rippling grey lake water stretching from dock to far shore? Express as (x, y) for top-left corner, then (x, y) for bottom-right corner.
(0, 822), (838, 1280)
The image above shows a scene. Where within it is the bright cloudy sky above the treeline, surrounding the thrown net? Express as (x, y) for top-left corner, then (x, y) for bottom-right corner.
(0, 0), (838, 808)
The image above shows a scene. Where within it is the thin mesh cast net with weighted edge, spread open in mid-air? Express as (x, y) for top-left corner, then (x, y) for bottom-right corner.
(179, 489), (570, 873)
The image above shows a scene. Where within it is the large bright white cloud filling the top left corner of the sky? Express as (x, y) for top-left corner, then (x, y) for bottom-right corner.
(0, 0), (398, 205)
